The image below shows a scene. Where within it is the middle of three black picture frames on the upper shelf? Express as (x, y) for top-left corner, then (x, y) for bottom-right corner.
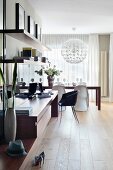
(28, 15), (35, 37)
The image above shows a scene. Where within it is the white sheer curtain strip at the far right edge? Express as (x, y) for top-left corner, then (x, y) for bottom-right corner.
(109, 33), (113, 102)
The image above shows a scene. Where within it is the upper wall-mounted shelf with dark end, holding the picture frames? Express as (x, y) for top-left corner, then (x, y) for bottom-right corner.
(0, 29), (51, 52)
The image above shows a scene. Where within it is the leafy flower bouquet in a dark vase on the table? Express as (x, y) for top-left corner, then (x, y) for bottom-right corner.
(44, 65), (62, 87)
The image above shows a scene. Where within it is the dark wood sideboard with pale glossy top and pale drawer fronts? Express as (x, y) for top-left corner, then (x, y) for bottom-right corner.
(16, 91), (58, 139)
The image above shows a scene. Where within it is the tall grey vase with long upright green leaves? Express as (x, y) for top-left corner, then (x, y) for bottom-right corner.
(0, 63), (17, 143)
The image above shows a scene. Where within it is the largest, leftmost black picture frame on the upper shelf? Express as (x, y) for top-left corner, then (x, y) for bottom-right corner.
(15, 3), (25, 29)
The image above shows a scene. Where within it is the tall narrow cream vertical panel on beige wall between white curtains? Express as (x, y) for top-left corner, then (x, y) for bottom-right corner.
(100, 51), (108, 97)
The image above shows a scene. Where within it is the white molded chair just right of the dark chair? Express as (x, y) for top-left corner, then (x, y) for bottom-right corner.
(74, 85), (89, 111)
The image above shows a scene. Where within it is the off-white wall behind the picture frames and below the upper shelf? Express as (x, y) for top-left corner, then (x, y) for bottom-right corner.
(6, 0), (41, 58)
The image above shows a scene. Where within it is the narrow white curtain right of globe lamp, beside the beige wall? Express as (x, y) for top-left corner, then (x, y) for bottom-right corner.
(88, 34), (99, 100)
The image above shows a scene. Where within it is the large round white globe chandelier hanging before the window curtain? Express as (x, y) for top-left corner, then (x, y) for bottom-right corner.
(61, 39), (88, 63)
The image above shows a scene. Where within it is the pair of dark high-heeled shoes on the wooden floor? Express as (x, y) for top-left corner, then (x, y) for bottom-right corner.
(32, 152), (45, 167)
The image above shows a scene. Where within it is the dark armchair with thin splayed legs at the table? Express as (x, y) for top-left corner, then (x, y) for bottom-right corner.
(58, 91), (79, 123)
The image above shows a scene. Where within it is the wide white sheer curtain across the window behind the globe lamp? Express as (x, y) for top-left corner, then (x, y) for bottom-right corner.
(43, 34), (89, 85)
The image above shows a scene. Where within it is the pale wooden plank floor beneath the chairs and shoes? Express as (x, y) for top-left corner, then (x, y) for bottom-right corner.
(21, 103), (113, 170)
